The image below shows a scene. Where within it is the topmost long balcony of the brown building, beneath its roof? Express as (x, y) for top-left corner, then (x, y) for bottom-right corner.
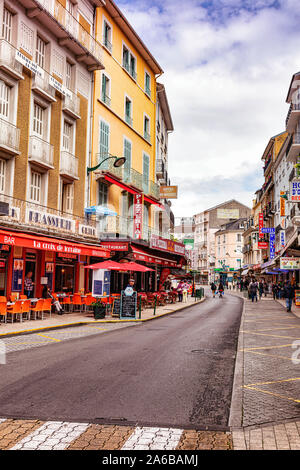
(19, 0), (104, 71)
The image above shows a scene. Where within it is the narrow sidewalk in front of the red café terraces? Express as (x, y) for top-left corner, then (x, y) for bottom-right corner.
(0, 297), (205, 338)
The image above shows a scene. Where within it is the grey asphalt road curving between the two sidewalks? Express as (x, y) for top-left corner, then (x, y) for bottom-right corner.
(0, 295), (242, 429)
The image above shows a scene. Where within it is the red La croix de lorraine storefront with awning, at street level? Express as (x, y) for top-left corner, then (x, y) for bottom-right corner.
(0, 229), (110, 297)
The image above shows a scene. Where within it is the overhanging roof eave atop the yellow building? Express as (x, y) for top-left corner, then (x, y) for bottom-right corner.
(104, 0), (163, 74)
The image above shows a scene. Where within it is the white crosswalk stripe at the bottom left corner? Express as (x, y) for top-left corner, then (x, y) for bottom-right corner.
(10, 421), (89, 450)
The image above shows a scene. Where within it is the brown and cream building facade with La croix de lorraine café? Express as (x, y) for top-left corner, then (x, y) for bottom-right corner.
(0, 0), (109, 296)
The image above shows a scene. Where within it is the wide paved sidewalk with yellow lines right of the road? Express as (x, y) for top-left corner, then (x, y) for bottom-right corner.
(229, 292), (300, 450)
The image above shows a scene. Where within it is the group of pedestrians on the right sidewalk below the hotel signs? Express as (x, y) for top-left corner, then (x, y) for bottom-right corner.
(248, 278), (295, 312)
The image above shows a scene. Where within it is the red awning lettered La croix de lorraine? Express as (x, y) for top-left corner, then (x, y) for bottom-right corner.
(0, 230), (110, 258)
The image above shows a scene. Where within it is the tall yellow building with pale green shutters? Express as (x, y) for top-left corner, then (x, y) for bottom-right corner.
(88, 0), (162, 241)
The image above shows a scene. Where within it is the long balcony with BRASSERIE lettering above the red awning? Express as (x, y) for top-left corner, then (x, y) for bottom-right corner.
(0, 194), (98, 241)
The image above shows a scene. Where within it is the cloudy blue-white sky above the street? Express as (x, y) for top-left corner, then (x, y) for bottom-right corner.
(117, 0), (300, 217)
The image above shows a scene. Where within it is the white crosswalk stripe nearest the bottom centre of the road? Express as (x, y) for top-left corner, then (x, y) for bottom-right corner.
(121, 427), (183, 450)
